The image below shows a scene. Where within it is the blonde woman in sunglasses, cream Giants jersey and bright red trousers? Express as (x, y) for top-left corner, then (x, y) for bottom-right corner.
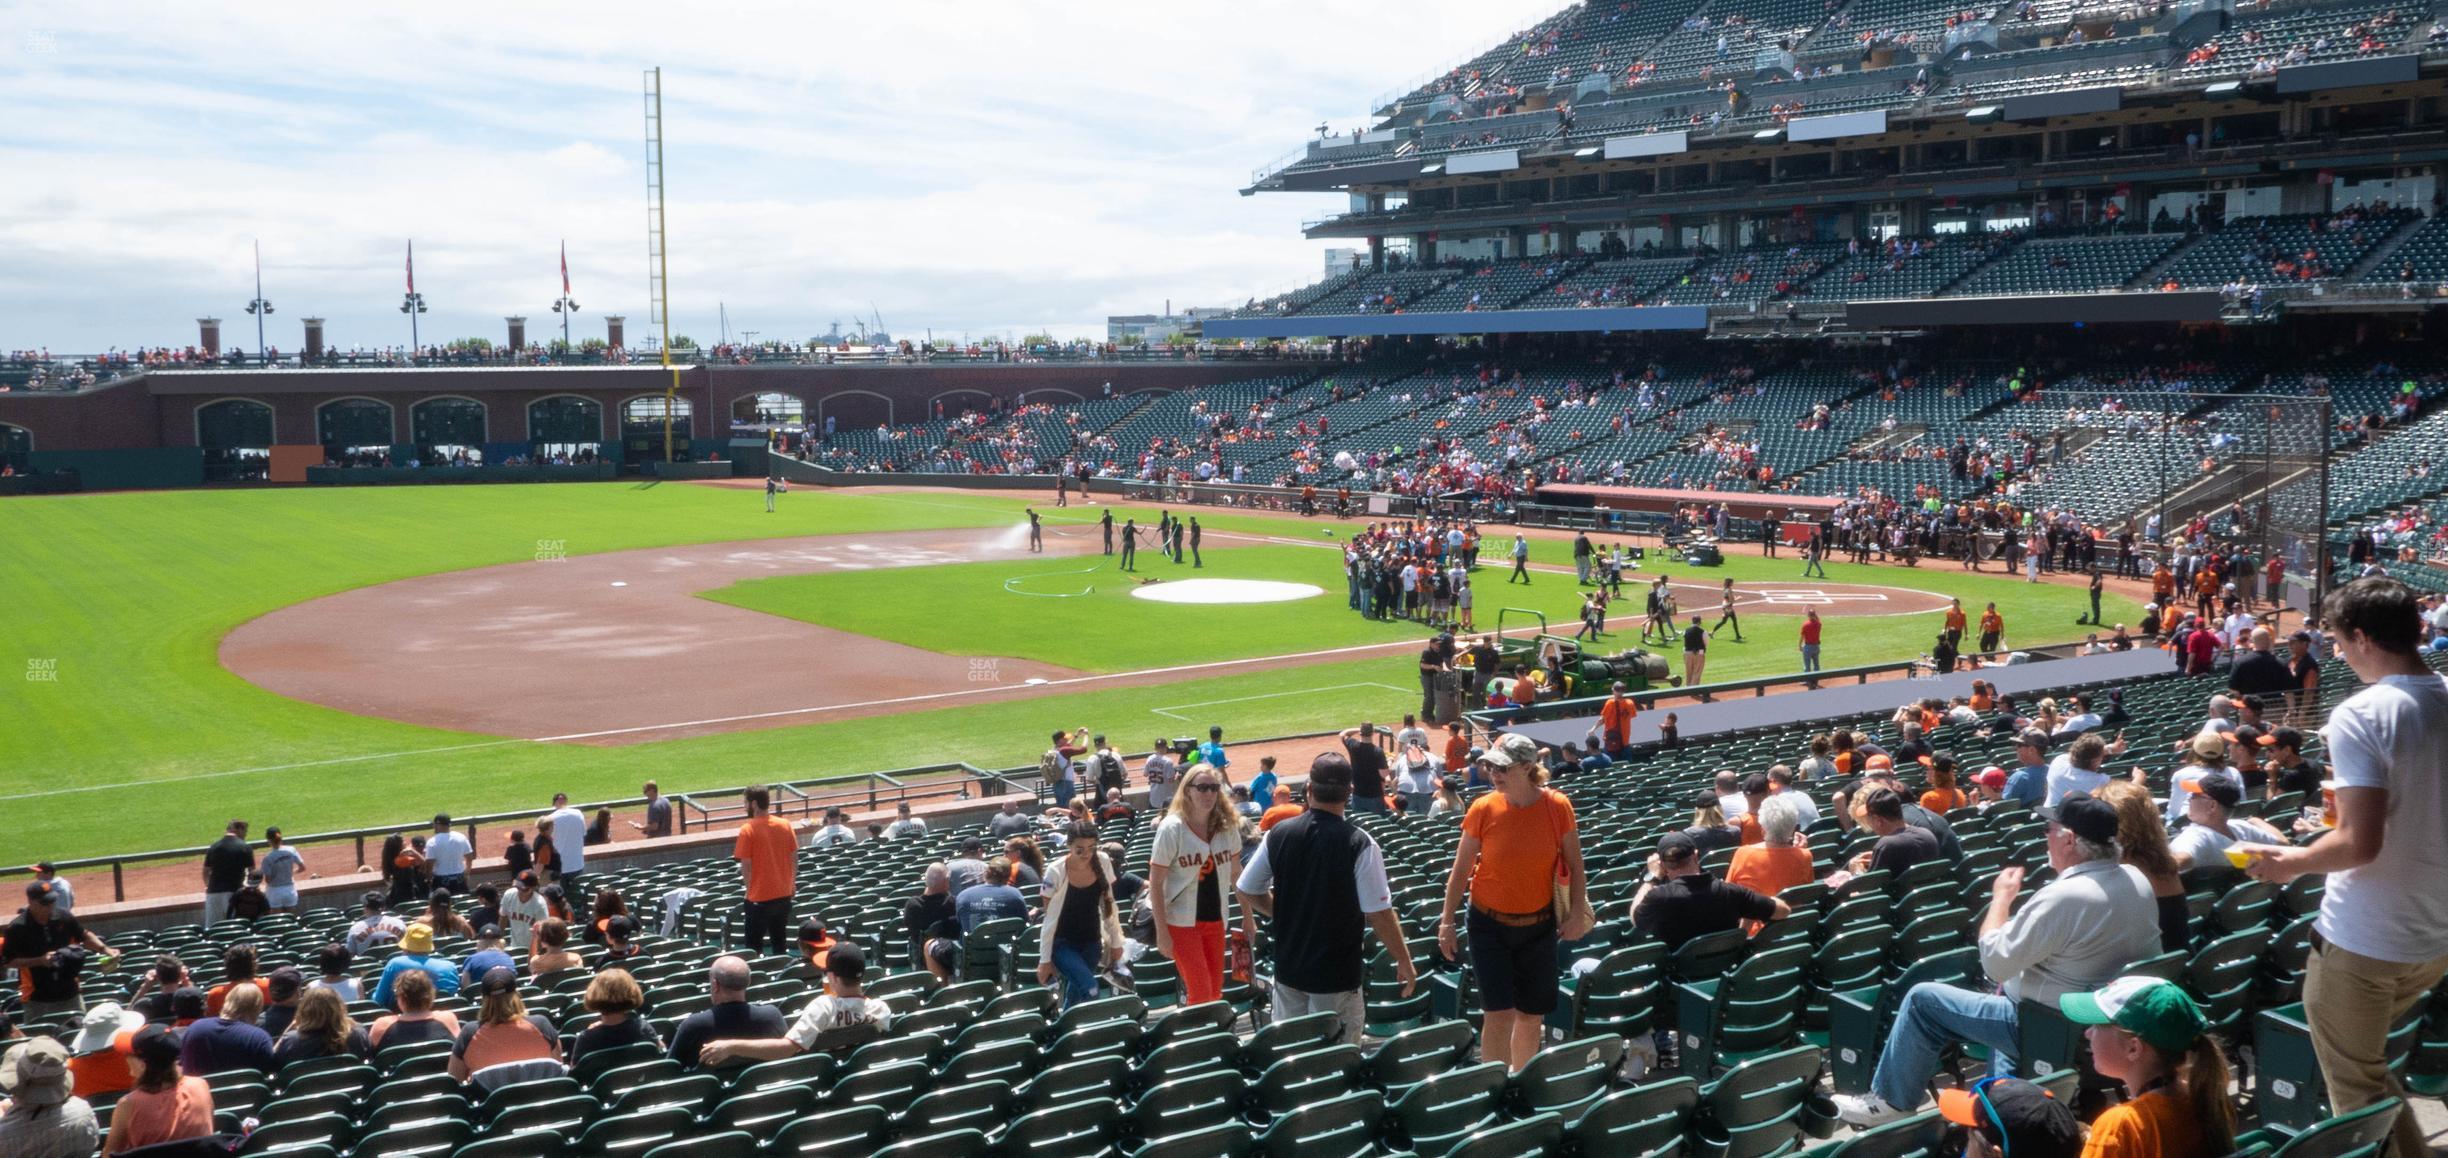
(1148, 761), (1241, 1006)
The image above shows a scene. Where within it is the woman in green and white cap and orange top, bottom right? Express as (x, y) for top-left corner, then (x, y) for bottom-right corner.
(2059, 977), (2242, 1156)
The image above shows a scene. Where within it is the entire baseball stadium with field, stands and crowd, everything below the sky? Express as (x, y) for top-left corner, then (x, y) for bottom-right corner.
(0, 9), (2448, 1158)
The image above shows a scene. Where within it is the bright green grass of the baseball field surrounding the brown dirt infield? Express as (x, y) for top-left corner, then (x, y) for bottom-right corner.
(0, 482), (2132, 859)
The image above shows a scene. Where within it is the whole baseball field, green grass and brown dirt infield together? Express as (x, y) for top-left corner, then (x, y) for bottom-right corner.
(0, 482), (2140, 862)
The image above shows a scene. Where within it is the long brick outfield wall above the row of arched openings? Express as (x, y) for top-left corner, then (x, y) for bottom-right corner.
(0, 362), (1319, 450)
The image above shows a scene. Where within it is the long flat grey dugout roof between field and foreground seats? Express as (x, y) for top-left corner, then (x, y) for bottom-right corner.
(1513, 649), (2174, 747)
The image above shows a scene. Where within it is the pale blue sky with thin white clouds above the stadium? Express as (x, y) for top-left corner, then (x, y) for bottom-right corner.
(0, 0), (1559, 353)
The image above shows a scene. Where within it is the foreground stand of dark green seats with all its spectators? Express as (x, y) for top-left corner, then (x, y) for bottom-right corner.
(14, 578), (2448, 1158)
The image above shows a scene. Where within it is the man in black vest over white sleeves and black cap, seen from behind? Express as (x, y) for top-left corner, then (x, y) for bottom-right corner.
(1234, 752), (1417, 1045)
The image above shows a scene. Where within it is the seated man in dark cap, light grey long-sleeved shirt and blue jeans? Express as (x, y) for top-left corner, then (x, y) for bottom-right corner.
(1836, 793), (2159, 1129)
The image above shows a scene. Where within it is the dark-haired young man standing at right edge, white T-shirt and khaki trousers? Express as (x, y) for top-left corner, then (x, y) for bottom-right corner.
(2247, 578), (2448, 1158)
